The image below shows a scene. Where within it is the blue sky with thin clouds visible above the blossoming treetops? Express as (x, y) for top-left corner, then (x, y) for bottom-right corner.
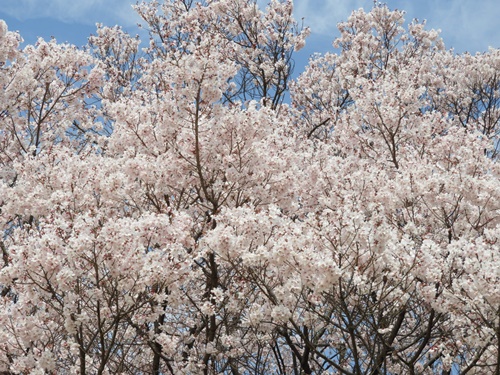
(0, 0), (500, 73)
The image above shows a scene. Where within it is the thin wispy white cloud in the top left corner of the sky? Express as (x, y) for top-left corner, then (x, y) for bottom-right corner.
(2, 0), (139, 26)
